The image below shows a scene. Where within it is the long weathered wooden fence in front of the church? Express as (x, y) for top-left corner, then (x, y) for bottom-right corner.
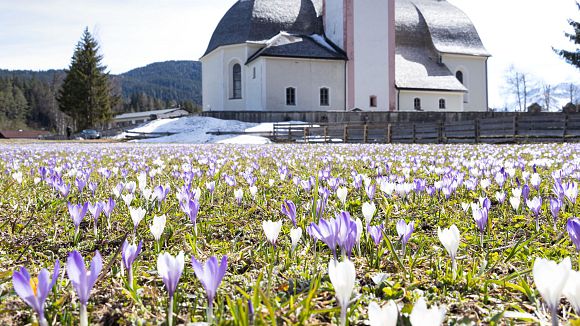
(273, 113), (580, 144)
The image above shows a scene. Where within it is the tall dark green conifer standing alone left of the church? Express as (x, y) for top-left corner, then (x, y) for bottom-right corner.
(57, 28), (119, 130)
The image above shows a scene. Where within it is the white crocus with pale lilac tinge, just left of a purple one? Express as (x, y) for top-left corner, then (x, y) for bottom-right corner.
(157, 251), (185, 326)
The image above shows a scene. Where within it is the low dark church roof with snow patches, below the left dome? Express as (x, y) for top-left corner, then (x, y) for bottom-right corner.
(247, 32), (346, 63)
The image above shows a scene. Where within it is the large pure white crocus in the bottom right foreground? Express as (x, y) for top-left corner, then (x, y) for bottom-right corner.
(532, 257), (572, 325)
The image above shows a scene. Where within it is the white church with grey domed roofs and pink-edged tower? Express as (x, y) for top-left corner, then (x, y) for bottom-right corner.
(200, 0), (490, 112)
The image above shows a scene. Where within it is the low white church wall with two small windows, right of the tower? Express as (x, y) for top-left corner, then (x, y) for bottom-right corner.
(398, 90), (464, 112)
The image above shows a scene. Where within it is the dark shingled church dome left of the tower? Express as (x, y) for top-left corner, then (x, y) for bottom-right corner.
(204, 0), (324, 55)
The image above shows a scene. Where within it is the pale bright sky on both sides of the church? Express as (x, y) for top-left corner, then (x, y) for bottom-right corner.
(0, 0), (580, 108)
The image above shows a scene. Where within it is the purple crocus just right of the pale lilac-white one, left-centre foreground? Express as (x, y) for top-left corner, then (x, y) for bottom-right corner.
(191, 256), (228, 324)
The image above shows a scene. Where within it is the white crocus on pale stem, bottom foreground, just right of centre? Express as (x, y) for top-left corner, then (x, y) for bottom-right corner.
(328, 259), (356, 325)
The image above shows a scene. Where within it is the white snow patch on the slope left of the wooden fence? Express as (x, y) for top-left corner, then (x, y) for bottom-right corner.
(117, 116), (288, 144)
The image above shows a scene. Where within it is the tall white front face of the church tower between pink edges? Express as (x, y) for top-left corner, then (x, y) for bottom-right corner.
(348, 0), (394, 111)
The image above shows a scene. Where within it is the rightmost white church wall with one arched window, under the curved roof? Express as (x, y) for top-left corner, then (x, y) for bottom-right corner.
(442, 54), (488, 111)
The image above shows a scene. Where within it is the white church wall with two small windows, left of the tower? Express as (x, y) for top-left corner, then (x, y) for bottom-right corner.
(261, 57), (345, 111)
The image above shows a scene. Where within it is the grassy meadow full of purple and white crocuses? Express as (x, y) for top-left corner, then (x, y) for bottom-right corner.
(0, 143), (580, 325)
